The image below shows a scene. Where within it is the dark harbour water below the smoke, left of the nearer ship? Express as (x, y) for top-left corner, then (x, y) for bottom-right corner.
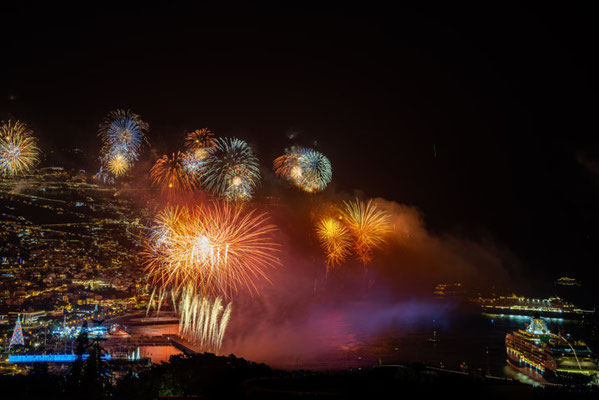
(260, 313), (592, 381)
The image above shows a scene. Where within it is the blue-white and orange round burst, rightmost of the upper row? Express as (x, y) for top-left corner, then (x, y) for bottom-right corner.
(273, 146), (333, 193)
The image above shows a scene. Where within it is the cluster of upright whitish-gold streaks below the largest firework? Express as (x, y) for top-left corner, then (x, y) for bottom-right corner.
(179, 287), (232, 353)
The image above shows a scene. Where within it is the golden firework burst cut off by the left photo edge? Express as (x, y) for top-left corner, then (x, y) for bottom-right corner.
(0, 120), (40, 177)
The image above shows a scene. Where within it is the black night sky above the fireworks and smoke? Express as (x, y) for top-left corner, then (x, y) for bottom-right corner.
(0, 5), (599, 279)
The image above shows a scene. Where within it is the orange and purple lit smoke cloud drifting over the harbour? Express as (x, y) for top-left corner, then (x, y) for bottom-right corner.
(223, 199), (517, 369)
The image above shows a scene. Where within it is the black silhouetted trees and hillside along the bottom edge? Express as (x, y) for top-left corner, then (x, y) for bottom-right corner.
(0, 353), (599, 400)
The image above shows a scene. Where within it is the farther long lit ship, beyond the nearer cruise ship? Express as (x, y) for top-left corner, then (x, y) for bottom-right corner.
(473, 294), (595, 320)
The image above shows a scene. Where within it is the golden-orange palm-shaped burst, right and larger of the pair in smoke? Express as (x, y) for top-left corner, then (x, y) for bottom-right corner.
(340, 199), (391, 264)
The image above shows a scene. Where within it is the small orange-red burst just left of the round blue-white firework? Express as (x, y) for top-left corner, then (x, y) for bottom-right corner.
(150, 151), (197, 192)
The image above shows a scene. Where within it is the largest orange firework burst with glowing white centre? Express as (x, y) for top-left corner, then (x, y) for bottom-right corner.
(145, 202), (279, 296)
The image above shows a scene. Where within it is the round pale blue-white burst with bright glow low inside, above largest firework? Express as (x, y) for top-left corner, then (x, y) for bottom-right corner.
(201, 138), (260, 201)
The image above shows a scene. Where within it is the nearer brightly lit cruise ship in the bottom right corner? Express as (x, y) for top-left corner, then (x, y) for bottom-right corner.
(505, 315), (599, 385)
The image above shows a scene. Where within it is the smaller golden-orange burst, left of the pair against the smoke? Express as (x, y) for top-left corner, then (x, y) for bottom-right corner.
(316, 217), (351, 269)
